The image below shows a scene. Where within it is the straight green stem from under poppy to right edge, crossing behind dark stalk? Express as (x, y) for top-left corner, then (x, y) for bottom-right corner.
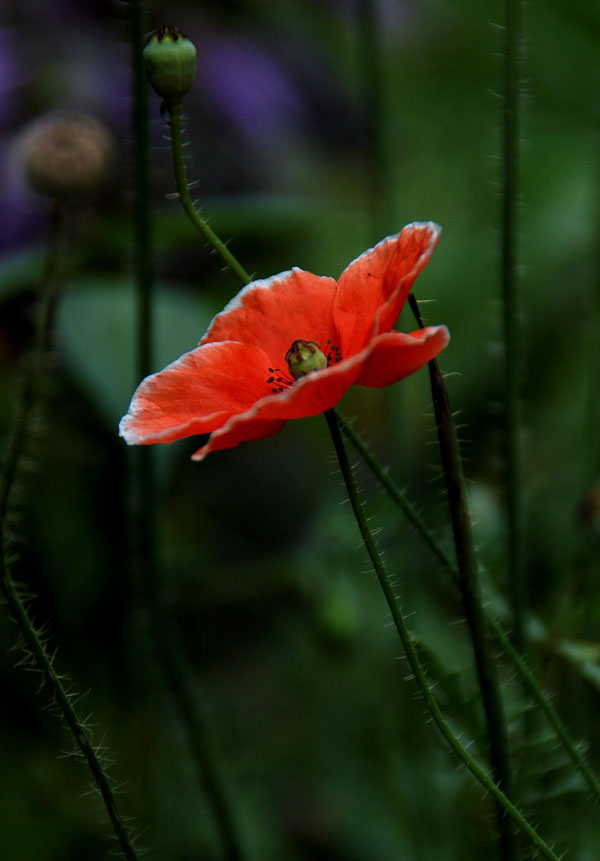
(337, 413), (600, 801)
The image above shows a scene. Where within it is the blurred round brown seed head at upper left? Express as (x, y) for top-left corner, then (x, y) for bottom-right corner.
(23, 111), (114, 199)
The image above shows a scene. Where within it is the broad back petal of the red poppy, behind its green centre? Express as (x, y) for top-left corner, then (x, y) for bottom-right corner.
(200, 269), (336, 368)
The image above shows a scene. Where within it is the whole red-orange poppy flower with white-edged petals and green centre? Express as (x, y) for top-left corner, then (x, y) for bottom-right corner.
(120, 222), (450, 460)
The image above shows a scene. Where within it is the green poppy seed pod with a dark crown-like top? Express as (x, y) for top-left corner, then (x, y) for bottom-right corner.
(144, 25), (196, 104)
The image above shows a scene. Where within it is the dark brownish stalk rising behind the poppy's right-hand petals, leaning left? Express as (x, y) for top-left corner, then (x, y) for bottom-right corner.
(409, 293), (516, 861)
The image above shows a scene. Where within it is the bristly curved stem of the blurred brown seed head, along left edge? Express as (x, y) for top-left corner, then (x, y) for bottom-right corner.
(0, 204), (137, 861)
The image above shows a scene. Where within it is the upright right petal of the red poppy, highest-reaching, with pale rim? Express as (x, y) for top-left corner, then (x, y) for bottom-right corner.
(333, 221), (441, 357)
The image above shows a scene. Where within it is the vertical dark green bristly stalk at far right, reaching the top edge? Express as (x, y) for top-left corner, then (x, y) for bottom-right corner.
(500, 0), (527, 652)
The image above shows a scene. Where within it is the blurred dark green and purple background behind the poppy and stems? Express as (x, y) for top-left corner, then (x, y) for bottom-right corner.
(0, 0), (600, 861)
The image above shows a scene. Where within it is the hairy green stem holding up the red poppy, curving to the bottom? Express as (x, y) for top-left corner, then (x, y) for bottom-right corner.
(325, 410), (558, 861)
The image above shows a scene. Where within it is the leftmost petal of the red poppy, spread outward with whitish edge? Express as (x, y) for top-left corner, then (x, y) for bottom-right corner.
(119, 341), (271, 445)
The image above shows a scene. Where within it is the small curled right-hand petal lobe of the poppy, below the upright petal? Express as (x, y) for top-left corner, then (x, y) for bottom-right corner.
(356, 326), (450, 388)
